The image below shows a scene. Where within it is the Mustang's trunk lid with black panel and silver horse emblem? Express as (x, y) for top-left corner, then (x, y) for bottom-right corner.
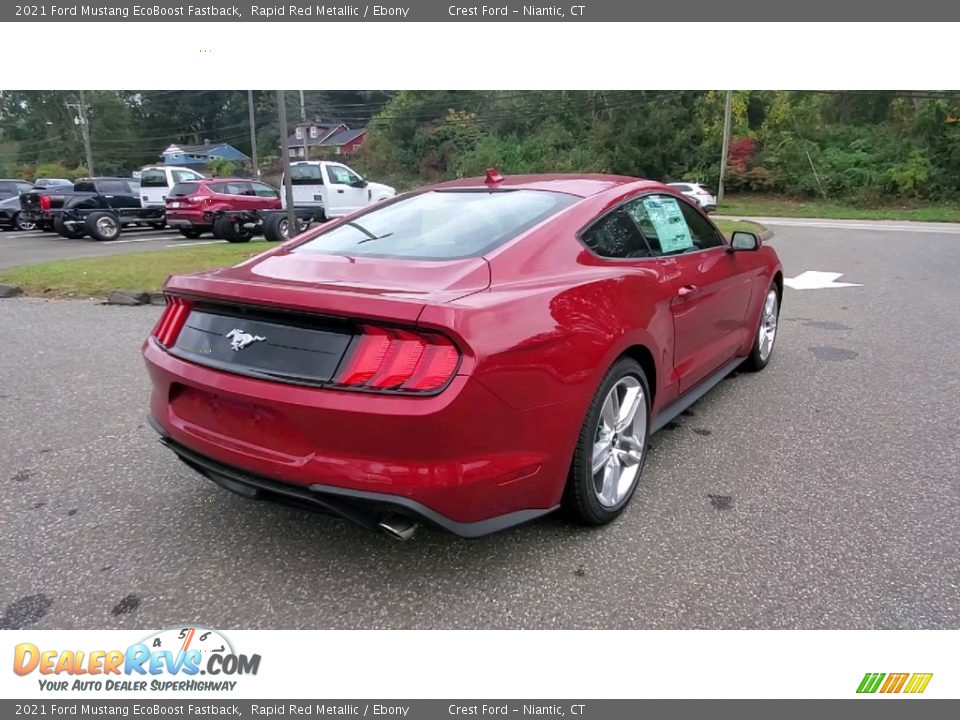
(165, 251), (490, 386)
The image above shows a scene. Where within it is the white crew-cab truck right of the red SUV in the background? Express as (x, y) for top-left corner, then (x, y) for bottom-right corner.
(280, 160), (397, 219)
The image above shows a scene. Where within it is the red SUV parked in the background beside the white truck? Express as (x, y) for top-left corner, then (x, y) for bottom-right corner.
(166, 178), (281, 242)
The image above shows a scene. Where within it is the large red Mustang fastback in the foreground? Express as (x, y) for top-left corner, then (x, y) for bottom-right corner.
(143, 171), (783, 539)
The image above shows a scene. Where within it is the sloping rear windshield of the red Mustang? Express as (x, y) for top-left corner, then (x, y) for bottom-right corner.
(293, 190), (577, 260)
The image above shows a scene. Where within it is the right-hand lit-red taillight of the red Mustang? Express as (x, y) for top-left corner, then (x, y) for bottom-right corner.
(333, 325), (460, 393)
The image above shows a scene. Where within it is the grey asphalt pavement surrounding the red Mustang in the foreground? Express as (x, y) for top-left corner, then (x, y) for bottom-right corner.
(0, 225), (960, 628)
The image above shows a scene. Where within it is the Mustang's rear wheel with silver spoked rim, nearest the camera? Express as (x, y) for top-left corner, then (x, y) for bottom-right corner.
(562, 357), (650, 525)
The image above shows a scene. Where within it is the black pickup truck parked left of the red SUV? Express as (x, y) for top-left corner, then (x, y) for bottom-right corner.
(20, 178), (165, 240)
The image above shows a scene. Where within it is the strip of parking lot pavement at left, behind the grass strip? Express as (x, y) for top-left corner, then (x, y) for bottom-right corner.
(0, 228), (225, 268)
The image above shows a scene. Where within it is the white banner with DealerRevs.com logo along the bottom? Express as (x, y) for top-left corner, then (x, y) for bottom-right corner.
(0, 625), (960, 700)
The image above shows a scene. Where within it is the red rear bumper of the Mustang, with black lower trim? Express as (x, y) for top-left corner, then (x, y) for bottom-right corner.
(144, 339), (580, 537)
